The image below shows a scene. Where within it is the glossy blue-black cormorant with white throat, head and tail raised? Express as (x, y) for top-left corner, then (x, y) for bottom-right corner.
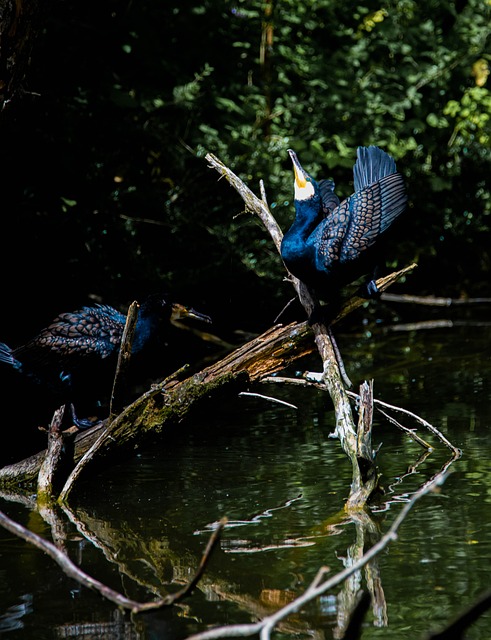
(281, 146), (407, 300)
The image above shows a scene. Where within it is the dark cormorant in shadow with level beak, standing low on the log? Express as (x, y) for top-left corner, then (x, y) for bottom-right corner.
(0, 294), (211, 428)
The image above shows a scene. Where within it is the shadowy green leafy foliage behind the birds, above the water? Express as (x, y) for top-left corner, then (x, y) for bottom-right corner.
(0, 0), (491, 342)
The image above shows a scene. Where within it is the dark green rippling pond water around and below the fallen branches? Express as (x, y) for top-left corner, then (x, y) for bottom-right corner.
(0, 326), (491, 640)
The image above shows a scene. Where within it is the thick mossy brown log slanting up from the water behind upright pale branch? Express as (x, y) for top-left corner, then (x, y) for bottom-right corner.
(0, 265), (415, 487)
